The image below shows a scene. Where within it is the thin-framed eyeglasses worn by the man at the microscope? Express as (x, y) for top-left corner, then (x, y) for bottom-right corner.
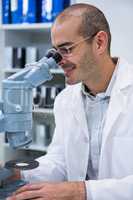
(55, 32), (97, 57)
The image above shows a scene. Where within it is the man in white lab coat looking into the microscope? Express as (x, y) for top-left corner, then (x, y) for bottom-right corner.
(7, 4), (133, 200)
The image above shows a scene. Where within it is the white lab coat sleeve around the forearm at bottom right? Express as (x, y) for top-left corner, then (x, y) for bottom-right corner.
(85, 176), (133, 200)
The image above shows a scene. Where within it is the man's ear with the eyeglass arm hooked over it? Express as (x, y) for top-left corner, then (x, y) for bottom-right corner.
(95, 31), (108, 55)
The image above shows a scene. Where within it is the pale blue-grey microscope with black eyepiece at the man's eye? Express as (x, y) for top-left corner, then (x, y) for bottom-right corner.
(0, 49), (62, 199)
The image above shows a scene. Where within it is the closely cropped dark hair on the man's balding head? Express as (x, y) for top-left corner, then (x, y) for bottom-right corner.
(57, 3), (111, 54)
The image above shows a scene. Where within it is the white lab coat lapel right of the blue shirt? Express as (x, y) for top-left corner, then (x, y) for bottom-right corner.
(103, 57), (133, 148)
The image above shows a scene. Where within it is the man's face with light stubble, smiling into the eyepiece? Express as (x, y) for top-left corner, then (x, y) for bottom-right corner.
(51, 17), (99, 85)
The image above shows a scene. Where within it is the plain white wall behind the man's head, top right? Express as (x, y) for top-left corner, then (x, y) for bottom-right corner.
(76, 0), (133, 63)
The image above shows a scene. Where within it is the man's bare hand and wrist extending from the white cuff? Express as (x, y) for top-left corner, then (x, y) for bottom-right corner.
(7, 182), (86, 200)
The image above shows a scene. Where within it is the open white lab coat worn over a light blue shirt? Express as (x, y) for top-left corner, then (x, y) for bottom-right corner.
(24, 59), (133, 200)
